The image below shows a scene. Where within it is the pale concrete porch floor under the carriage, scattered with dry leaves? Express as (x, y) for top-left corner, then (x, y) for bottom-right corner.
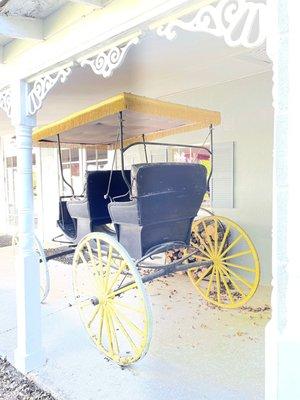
(0, 247), (270, 400)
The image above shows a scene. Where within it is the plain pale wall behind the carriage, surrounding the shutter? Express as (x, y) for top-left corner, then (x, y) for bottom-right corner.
(157, 73), (273, 284)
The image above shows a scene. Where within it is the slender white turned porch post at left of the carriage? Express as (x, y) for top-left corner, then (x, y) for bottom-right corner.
(11, 80), (44, 373)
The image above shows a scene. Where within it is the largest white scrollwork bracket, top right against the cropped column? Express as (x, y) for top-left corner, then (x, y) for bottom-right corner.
(157, 0), (267, 48)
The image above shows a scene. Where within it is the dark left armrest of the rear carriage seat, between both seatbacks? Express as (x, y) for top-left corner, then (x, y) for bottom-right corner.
(108, 200), (138, 224)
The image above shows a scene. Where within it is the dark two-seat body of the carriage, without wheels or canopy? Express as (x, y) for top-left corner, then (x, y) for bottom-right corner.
(58, 163), (207, 260)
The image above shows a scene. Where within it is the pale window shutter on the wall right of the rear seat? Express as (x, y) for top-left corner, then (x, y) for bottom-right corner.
(212, 142), (234, 208)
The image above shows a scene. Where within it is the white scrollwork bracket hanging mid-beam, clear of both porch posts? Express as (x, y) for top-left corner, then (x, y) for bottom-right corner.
(77, 36), (139, 78)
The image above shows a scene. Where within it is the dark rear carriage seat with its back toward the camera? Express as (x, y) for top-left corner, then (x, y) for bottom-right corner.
(108, 163), (206, 259)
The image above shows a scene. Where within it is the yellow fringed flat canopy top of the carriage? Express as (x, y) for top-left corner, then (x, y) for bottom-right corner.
(33, 93), (221, 150)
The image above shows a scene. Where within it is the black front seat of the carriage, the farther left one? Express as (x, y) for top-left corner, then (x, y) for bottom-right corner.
(66, 171), (130, 240)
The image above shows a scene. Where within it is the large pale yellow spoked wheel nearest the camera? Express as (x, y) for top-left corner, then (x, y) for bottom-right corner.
(73, 232), (152, 365)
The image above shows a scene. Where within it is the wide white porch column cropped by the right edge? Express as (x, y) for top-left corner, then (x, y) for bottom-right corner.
(265, 0), (300, 400)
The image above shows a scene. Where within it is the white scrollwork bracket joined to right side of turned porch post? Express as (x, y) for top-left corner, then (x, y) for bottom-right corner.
(27, 64), (73, 115)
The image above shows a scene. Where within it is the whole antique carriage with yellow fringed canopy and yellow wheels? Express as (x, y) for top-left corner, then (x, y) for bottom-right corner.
(33, 93), (259, 365)
